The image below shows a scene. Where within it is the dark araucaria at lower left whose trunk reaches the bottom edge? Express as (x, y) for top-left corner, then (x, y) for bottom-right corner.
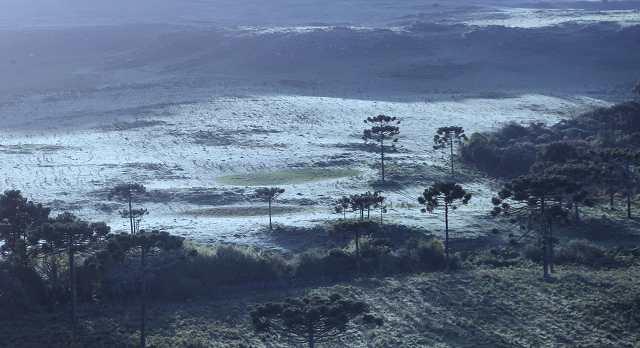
(107, 230), (189, 347)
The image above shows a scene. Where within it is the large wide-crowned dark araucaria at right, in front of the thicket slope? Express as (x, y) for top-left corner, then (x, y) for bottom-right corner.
(491, 174), (582, 280)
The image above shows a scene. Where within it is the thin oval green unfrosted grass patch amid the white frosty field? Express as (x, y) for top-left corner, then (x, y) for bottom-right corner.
(216, 168), (362, 186)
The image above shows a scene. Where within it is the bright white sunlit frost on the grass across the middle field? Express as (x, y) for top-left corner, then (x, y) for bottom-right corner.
(0, 93), (603, 251)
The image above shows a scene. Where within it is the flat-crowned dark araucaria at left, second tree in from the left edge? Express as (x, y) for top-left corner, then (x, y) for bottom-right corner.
(29, 213), (110, 337)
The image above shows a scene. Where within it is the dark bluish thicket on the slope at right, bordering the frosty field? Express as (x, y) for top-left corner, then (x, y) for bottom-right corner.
(461, 101), (640, 178)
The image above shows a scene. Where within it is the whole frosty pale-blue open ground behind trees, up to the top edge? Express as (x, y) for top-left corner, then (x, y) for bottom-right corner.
(0, 0), (640, 251)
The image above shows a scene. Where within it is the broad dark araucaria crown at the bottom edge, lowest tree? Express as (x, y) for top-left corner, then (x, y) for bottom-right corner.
(249, 294), (383, 348)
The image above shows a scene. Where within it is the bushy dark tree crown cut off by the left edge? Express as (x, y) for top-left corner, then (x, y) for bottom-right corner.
(0, 190), (51, 264)
